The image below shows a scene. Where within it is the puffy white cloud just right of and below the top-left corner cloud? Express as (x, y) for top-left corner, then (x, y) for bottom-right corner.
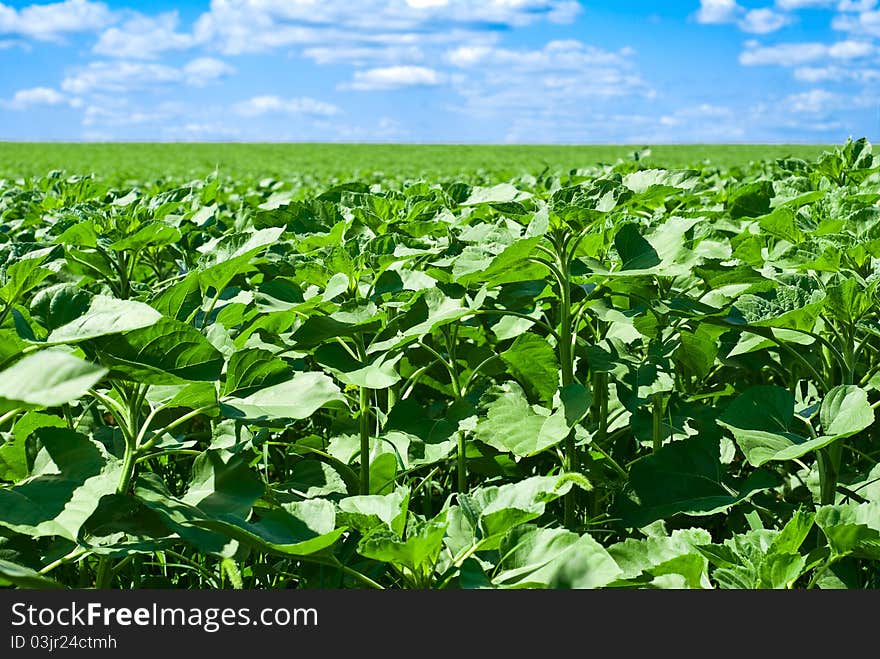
(92, 11), (195, 59)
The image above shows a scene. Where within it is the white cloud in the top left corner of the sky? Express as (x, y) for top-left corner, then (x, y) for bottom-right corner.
(0, 0), (114, 41)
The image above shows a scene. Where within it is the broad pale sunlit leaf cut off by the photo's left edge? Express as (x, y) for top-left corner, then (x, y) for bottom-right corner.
(0, 350), (107, 413)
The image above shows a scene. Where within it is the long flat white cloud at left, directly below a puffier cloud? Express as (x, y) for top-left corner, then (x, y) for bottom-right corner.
(61, 57), (233, 94)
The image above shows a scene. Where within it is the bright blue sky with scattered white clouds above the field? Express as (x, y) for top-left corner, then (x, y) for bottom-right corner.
(0, 0), (880, 143)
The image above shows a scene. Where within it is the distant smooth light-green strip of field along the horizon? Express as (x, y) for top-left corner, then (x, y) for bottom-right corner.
(0, 142), (828, 180)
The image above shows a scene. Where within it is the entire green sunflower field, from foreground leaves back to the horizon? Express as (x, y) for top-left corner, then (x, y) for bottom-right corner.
(0, 140), (880, 592)
